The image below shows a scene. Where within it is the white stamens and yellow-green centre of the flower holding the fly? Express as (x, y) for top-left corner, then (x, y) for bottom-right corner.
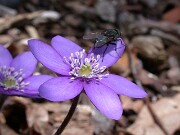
(64, 49), (108, 80)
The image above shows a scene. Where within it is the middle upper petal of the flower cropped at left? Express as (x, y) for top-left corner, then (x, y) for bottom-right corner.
(11, 52), (37, 78)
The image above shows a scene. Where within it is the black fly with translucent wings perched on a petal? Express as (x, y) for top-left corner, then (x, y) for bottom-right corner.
(83, 29), (121, 60)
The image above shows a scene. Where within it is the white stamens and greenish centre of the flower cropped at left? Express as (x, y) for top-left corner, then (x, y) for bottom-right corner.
(0, 66), (29, 91)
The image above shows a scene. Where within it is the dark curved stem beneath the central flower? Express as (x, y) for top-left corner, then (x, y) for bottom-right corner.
(54, 95), (80, 135)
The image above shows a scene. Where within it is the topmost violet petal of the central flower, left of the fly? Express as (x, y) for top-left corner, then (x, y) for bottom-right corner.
(51, 36), (82, 58)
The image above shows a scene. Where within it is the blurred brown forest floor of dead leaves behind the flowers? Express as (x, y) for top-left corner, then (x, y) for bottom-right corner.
(0, 0), (180, 135)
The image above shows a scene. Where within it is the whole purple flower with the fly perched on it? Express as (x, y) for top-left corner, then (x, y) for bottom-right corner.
(28, 36), (147, 120)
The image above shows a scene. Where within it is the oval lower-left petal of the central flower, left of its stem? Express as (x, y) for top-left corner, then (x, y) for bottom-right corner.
(39, 77), (83, 101)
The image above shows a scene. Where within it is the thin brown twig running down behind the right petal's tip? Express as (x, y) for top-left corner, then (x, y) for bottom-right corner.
(127, 46), (168, 135)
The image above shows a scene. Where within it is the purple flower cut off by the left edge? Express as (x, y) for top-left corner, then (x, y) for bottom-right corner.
(0, 45), (52, 98)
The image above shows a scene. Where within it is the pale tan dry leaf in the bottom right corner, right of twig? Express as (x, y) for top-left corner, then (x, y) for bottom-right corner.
(152, 94), (180, 135)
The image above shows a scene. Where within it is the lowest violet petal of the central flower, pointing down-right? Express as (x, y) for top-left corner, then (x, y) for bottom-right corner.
(84, 81), (123, 120)
